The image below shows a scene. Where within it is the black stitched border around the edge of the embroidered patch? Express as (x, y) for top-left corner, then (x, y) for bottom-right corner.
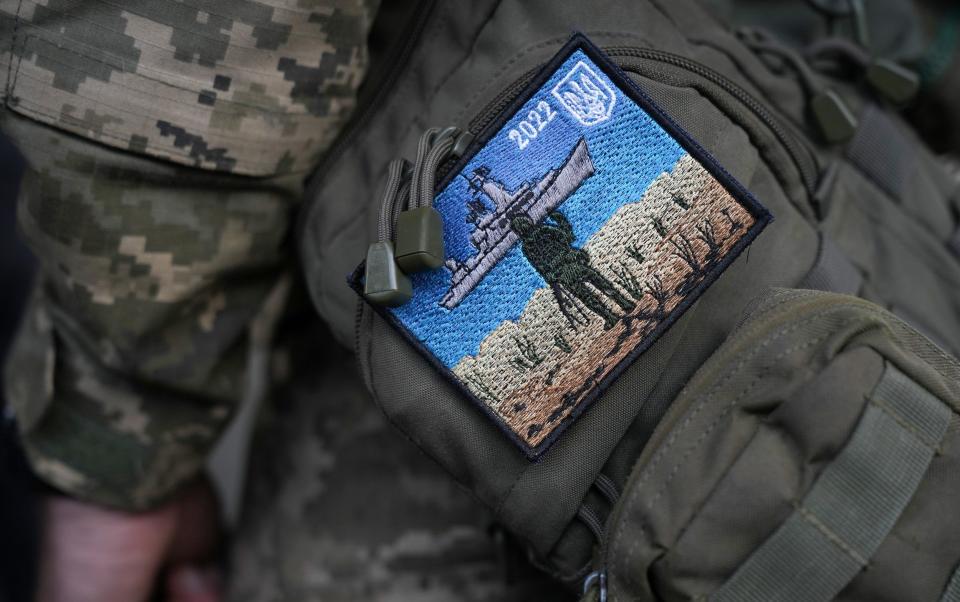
(347, 32), (773, 461)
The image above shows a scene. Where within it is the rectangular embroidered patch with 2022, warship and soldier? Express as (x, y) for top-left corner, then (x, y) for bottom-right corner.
(358, 35), (771, 458)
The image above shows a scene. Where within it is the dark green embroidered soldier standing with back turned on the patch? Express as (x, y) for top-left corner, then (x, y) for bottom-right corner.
(510, 211), (636, 330)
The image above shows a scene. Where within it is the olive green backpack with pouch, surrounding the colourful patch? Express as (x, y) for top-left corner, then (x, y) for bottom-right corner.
(299, 0), (960, 601)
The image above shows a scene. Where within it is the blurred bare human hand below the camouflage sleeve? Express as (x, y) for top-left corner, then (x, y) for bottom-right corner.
(37, 481), (222, 602)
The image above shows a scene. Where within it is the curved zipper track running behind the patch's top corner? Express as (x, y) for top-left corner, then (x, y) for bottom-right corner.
(467, 47), (819, 202)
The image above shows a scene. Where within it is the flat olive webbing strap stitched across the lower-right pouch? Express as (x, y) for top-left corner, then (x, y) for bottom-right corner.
(710, 364), (952, 602)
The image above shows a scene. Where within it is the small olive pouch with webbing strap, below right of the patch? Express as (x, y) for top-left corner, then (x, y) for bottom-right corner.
(597, 290), (960, 601)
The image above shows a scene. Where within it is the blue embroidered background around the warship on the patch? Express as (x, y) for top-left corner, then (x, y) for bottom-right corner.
(391, 50), (686, 368)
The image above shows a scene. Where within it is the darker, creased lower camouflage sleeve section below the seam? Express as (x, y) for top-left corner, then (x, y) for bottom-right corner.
(2, 108), (298, 509)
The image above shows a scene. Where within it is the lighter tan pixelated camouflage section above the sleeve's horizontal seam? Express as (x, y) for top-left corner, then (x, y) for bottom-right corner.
(0, 0), (373, 176)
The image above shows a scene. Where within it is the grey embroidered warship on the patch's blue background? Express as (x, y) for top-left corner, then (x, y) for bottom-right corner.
(440, 138), (594, 309)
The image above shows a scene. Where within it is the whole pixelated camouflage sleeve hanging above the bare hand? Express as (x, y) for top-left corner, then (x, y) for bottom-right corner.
(0, 0), (376, 509)
